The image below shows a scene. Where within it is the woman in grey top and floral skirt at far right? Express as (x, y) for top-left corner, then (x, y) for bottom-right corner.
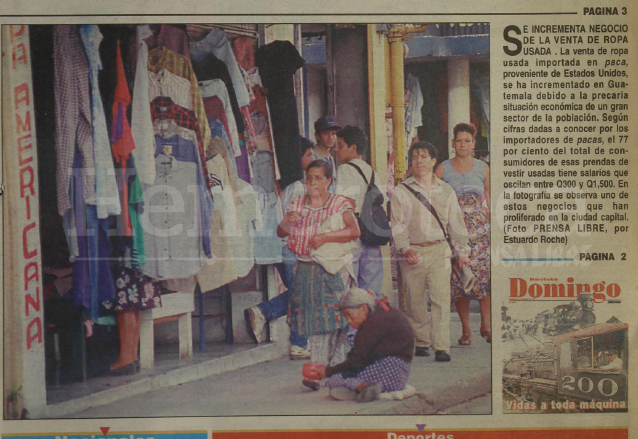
(434, 123), (492, 346)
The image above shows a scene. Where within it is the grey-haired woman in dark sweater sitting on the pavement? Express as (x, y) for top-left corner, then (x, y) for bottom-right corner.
(308, 288), (414, 402)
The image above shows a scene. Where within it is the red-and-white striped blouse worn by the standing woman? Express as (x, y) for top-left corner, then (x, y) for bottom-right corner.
(286, 194), (352, 257)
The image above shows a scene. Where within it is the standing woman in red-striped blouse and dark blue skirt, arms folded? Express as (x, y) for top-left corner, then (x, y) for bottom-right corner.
(277, 160), (361, 390)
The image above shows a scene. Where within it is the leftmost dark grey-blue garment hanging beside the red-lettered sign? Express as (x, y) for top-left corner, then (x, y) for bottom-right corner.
(53, 25), (96, 215)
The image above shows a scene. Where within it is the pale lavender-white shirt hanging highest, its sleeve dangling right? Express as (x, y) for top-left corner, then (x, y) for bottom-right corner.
(190, 28), (250, 107)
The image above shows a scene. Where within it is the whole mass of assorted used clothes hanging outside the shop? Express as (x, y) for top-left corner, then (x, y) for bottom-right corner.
(47, 25), (282, 320)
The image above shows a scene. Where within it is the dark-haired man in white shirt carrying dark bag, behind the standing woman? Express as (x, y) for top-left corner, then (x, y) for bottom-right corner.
(335, 125), (386, 299)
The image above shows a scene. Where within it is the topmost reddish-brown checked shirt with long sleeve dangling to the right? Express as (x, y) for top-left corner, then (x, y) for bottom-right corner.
(148, 47), (210, 156)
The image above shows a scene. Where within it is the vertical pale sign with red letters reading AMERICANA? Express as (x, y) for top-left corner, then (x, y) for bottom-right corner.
(2, 25), (45, 420)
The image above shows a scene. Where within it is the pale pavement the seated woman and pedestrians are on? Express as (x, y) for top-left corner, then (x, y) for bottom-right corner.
(62, 313), (492, 418)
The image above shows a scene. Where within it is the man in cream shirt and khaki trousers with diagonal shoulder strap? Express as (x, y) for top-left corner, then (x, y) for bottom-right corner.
(391, 142), (470, 361)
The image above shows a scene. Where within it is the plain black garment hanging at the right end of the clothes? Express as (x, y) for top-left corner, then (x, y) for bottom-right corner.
(255, 41), (305, 188)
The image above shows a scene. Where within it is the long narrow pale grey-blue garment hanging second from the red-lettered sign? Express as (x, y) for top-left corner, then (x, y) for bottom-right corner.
(80, 24), (121, 219)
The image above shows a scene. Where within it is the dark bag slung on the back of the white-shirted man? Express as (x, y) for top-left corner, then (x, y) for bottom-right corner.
(348, 163), (392, 246)
